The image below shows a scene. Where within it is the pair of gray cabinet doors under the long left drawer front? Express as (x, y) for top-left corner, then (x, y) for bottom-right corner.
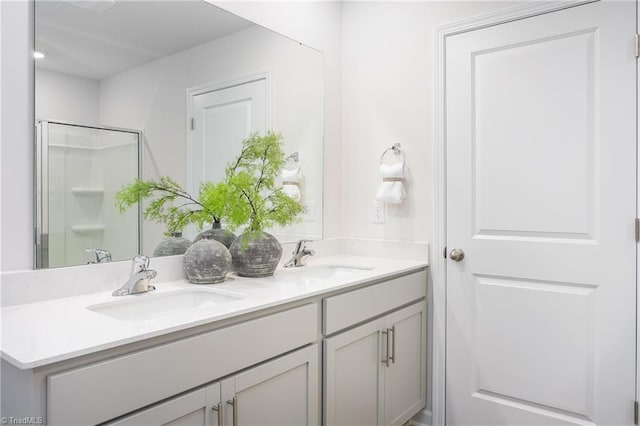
(107, 345), (320, 426)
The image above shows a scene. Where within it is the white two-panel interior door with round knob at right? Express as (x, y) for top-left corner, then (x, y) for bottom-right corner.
(446, 1), (636, 425)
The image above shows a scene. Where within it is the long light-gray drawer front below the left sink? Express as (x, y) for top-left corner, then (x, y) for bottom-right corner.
(47, 304), (318, 425)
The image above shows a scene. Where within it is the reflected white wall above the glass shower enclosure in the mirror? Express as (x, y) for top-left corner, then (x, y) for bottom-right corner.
(35, 69), (98, 124)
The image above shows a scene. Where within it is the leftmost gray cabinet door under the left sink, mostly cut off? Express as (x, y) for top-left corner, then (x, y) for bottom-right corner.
(107, 384), (222, 426)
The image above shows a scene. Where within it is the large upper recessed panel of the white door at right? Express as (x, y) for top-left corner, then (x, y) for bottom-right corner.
(470, 28), (597, 239)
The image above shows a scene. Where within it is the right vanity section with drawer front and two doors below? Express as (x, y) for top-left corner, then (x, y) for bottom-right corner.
(323, 272), (427, 425)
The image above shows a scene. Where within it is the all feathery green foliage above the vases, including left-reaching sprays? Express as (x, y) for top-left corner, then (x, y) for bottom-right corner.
(116, 132), (304, 235)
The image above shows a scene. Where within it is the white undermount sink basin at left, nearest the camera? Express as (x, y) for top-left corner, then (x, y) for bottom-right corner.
(87, 288), (245, 321)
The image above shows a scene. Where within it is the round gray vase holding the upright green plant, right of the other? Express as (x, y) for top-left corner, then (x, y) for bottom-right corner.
(229, 232), (282, 278)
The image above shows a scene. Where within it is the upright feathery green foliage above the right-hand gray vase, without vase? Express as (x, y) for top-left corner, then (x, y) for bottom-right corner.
(225, 132), (304, 233)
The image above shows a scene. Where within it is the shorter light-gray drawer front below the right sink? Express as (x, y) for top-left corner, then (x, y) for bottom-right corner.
(322, 271), (427, 335)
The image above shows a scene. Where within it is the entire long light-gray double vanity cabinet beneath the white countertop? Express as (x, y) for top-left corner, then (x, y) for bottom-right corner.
(1, 264), (427, 426)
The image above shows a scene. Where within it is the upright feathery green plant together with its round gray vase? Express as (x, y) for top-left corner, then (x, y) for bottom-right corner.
(225, 132), (304, 277)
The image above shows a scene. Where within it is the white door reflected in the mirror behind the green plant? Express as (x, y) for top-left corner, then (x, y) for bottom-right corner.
(186, 76), (268, 237)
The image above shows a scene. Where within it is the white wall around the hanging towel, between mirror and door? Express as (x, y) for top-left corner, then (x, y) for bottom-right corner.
(341, 1), (524, 242)
